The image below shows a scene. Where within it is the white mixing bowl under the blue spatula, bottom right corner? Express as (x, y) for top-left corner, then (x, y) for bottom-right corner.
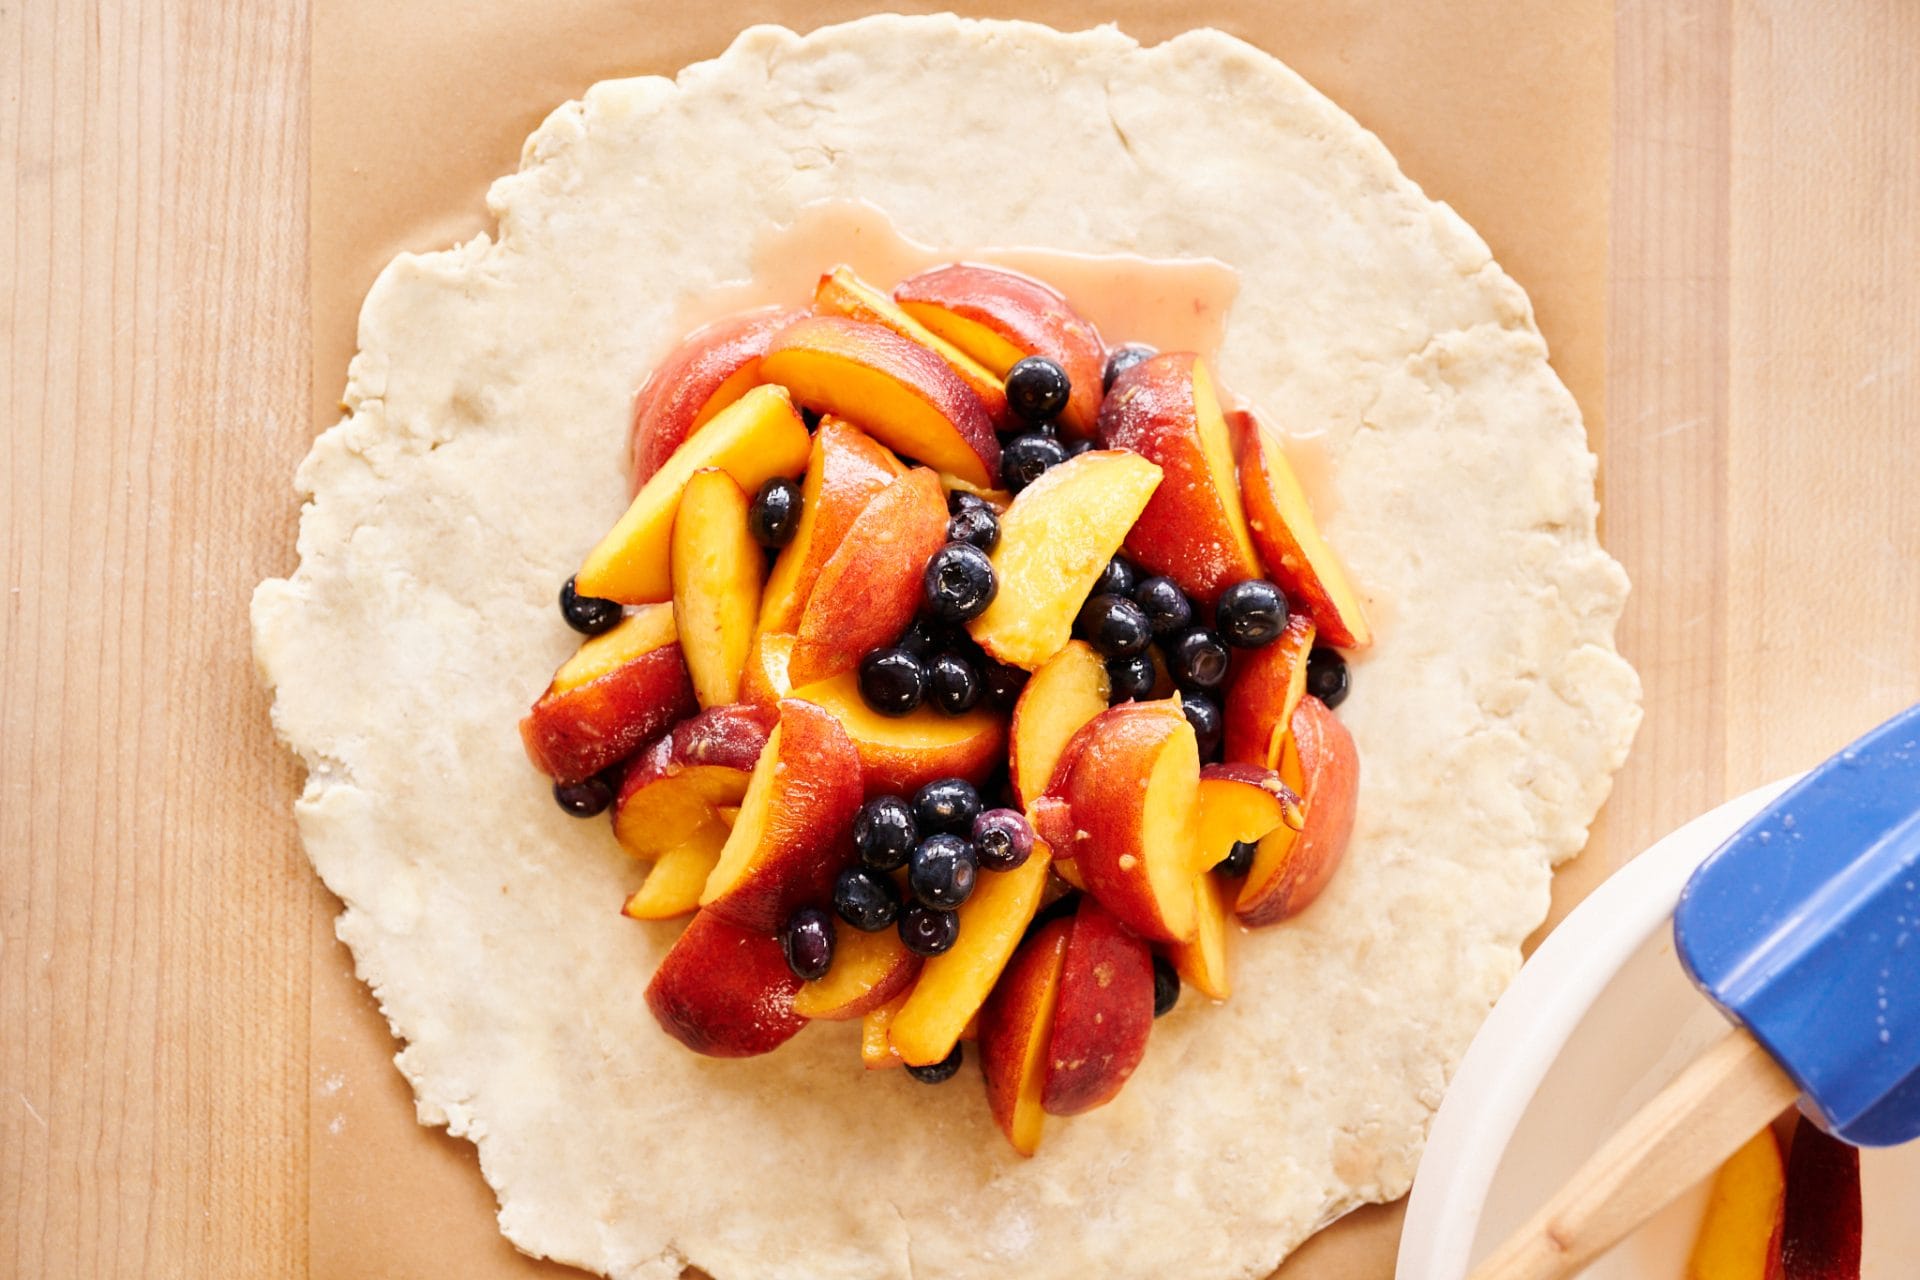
(1396, 779), (1920, 1280)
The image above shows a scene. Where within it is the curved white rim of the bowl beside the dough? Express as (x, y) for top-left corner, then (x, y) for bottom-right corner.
(1394, 775), (1799, 1280)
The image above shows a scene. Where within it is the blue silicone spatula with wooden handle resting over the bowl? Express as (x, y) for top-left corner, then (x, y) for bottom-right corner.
(1473, 706), (1920, 1280)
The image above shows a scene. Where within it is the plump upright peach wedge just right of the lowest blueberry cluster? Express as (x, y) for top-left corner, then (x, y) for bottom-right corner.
(1037, 699), (1200, 942)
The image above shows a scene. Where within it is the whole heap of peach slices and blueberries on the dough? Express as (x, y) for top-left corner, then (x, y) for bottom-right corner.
(520, 265), (1373, 1155)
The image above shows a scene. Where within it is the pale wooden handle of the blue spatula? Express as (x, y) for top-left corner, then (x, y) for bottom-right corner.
(1471, 1031), (1799, 1280)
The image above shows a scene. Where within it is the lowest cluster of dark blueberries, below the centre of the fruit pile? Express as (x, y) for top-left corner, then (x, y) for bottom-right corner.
(780, 777), (1033, 1082)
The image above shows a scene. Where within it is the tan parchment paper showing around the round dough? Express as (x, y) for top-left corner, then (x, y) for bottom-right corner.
(307, 0), (1613, 1280)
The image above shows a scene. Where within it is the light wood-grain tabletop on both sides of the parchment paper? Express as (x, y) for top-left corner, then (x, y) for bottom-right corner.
(0, 0), (1920, 1276)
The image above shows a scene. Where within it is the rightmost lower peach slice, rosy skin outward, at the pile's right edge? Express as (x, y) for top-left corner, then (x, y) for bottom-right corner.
(1233, 695), (1359, 925)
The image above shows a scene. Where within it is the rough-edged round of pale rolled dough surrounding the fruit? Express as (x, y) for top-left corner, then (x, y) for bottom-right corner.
(253, 17), (1638, 1280)
